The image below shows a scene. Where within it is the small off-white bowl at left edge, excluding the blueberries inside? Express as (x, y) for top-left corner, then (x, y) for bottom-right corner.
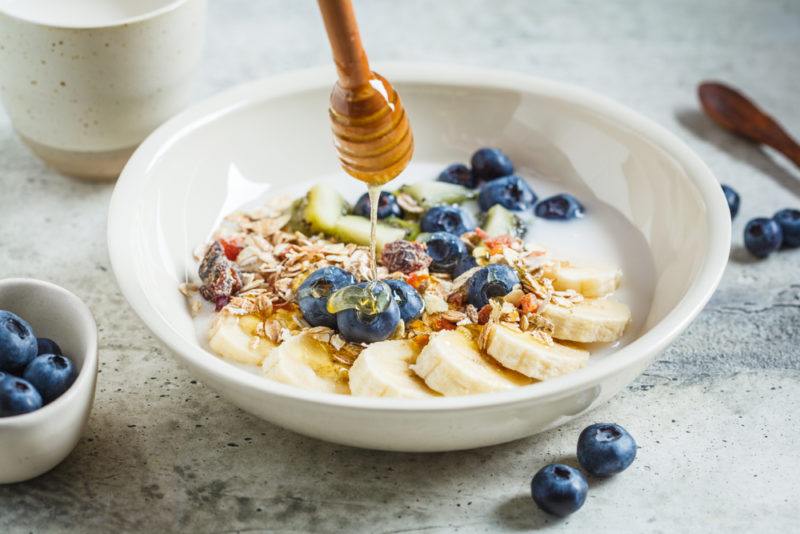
(0, 278), (97, 484)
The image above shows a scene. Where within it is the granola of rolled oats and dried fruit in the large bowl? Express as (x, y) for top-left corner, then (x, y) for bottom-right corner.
(181, 200), (583, 365)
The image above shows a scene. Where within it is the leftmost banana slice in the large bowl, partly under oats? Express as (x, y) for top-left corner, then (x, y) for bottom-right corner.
(208, 313), (275, 365)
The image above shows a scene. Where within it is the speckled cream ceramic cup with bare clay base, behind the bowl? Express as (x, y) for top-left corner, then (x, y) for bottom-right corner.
(0, 0), (206, 179)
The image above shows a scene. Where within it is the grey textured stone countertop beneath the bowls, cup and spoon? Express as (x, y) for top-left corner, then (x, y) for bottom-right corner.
(0, 0), (800, 533)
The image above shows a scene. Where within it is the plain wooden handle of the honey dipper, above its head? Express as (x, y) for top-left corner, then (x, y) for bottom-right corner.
(317, 0), (371, 89)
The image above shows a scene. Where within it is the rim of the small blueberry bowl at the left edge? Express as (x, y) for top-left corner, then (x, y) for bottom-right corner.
(0, 278), (98, 430)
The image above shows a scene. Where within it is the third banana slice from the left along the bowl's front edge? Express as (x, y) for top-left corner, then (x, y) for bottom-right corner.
(350, 340), (436, 399)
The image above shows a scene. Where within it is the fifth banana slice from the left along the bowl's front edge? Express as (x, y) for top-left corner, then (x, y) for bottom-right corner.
(486, 324), (589, 380)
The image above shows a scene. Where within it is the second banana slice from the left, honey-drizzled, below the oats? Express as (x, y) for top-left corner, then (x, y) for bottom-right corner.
(262, 334), (350, 395)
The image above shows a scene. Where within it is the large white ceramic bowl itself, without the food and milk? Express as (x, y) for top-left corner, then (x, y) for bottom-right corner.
(108, 65), (730, 451)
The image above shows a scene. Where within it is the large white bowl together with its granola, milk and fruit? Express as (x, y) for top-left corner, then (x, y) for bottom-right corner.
(108, 65), (730, 451)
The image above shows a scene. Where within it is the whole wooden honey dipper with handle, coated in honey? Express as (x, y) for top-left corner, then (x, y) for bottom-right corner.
(318, 0), (414, 186)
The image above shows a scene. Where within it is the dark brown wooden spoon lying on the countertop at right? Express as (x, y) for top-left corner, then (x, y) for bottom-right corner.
(697, 82), (800, 167)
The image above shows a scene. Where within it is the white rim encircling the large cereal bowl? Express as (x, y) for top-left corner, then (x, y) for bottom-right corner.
(108, 63), (731, 412)
